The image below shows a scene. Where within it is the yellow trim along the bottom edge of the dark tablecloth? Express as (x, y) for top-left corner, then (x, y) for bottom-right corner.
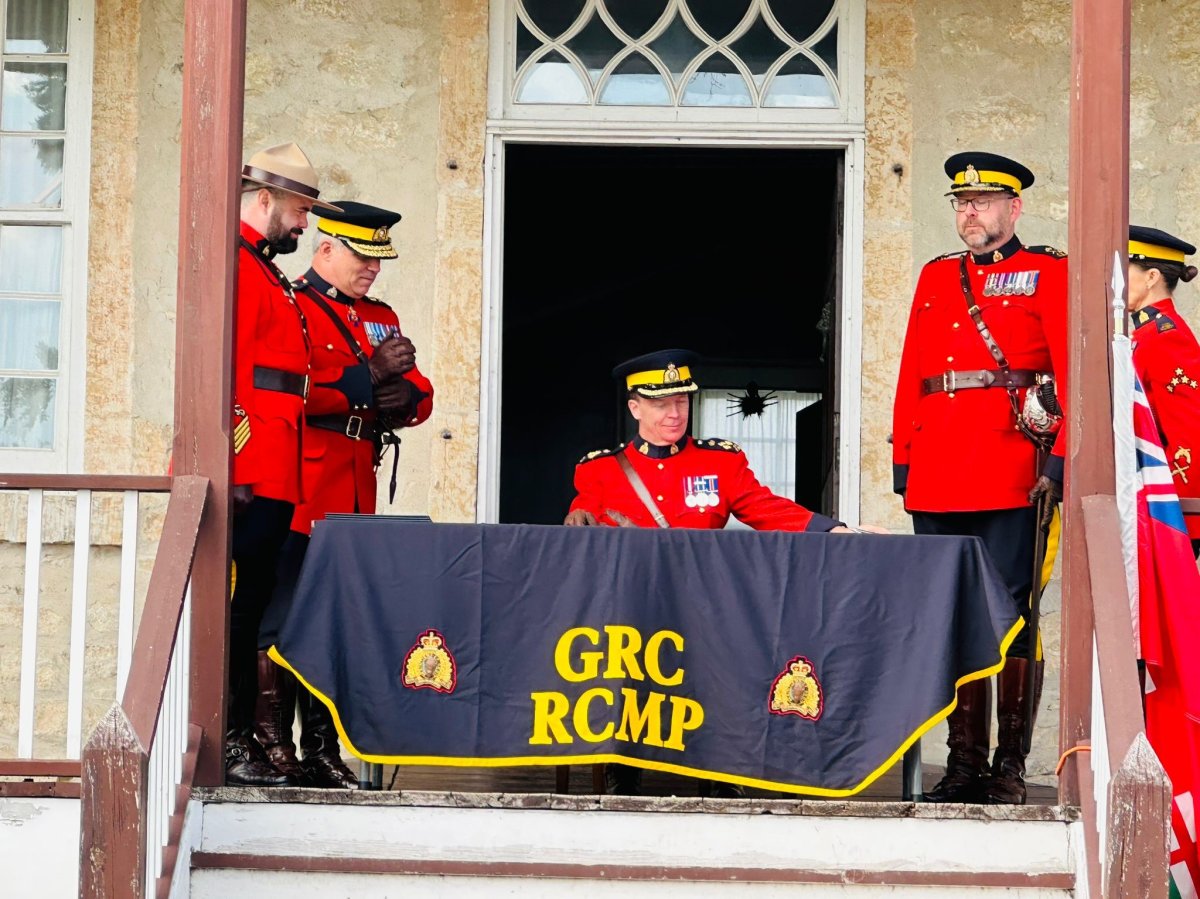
(268, 619), (1025, 798)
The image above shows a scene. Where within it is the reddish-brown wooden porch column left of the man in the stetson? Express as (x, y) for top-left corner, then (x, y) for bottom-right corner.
(174, 0), (246, 786)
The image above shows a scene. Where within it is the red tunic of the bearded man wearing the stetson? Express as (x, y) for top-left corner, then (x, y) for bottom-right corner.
(232, 222), (308, 503)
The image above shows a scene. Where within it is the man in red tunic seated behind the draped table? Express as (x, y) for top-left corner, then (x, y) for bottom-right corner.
(563, 349), (864, 796)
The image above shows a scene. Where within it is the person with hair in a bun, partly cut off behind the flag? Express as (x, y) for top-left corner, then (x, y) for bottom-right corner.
(1128, 224), (1200, 552)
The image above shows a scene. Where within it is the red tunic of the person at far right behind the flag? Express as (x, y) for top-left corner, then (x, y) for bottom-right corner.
(1133, 298), (1200, 540)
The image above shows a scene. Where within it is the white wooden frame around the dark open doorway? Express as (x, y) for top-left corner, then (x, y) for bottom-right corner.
(475, 0), (866, 525)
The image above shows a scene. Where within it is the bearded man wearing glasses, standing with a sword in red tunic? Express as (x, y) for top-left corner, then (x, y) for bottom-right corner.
(892, 152), (1067, 804)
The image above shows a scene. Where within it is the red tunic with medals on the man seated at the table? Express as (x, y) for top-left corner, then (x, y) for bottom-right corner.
(571, 437), (838, 531)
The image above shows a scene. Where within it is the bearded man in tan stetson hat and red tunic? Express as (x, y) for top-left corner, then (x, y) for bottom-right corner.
(226, 144), (336, 786)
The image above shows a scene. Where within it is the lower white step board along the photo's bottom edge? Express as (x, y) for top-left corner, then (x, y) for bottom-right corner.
(191, 869), (1070, 899)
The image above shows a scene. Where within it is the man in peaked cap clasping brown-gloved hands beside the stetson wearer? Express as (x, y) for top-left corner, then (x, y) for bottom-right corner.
(254, 200), (433, 789)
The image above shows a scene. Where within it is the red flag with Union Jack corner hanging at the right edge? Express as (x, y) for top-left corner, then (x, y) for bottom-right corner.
(1133, 382), (1200, 899)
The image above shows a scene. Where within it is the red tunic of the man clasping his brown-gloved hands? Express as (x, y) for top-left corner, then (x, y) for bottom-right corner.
(292, 270), (433, 534)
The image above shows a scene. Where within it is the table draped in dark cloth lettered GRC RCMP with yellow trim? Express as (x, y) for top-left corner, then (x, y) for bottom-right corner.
(272, 516), (1022, 797)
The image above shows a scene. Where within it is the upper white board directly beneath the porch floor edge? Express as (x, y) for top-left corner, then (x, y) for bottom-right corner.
(202, 803), (1074, 874)
